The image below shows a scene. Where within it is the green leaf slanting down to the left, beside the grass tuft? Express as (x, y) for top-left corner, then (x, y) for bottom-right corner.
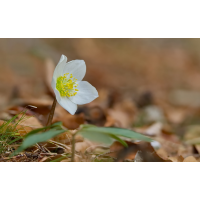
(12, 128), (65, 156)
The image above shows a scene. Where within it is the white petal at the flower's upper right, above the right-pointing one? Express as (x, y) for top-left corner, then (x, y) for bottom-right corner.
(63, 60), (86, 81)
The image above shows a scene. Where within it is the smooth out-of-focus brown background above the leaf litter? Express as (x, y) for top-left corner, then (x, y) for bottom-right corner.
(0, 38), (200, 108)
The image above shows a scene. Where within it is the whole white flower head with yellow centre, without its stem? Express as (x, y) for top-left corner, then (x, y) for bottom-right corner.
(51, 55), (99, 115)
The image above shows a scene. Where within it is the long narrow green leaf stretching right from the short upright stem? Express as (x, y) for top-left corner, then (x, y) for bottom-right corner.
(80, 125), (153, 142)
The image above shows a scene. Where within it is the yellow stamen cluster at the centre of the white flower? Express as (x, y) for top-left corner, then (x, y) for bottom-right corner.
(56, 73), (78, 97)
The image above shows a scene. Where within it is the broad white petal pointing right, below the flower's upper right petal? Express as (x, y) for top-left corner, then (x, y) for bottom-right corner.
(69, 81), (99, 105)
